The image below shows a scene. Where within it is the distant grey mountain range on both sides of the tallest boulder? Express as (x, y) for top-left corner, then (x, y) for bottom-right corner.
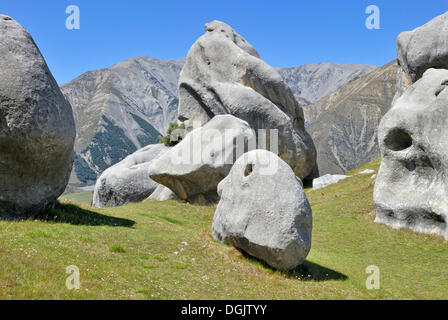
(61, 57), (375, 184)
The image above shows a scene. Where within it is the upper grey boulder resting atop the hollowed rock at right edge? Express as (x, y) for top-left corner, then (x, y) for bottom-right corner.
(397, 12), (448, 97)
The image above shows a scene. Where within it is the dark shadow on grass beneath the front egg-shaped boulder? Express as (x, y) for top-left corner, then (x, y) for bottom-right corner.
(238, 249), (348, 281)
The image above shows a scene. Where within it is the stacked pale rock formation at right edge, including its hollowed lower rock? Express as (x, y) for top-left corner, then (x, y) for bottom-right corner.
(374, 13), (448, 240)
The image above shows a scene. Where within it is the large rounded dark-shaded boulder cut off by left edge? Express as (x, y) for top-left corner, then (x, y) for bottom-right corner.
(0, 15), (76, 219)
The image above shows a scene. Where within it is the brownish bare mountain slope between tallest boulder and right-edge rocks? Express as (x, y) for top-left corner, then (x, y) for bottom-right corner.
(304, 61), (397, 175)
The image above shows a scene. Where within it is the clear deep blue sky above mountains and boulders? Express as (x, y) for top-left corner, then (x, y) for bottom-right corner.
(0, 0), (448, 84)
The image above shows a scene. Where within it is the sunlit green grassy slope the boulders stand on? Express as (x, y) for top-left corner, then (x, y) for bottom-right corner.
(0, 160), (448, 299)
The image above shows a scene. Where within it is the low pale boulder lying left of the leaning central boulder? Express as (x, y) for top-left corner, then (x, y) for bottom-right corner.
(92, 144), (170, 208)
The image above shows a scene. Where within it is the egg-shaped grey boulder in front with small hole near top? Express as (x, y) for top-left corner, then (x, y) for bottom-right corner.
(212, 150), (312, 270)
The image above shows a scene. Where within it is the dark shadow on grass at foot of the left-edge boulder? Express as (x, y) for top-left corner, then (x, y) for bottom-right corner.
(38, 202), (135, 228)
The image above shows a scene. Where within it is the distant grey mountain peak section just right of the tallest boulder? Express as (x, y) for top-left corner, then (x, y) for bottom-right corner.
(277, 62), (377, 105)
